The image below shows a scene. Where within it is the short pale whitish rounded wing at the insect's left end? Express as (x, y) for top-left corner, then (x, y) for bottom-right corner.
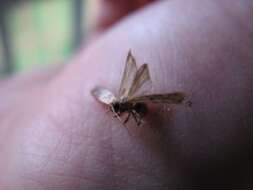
(91, 87), (116, 104)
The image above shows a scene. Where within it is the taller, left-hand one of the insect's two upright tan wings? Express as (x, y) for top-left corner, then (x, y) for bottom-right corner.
(119, 51), (137, 99)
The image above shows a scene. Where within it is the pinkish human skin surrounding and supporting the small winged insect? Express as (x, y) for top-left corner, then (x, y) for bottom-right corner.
(0, 0), (253, 190)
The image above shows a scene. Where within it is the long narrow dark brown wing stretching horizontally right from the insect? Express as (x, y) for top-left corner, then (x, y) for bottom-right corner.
(129, 92), (185, 104)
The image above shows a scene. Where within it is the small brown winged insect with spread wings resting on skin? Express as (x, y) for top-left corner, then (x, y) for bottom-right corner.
(91, 51), (185, 126)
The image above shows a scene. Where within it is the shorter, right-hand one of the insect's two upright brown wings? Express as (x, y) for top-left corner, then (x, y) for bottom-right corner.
(128, 64), (152, 99)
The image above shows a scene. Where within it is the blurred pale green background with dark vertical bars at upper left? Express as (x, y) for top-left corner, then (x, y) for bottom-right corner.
(0, 0), (98, 78)
